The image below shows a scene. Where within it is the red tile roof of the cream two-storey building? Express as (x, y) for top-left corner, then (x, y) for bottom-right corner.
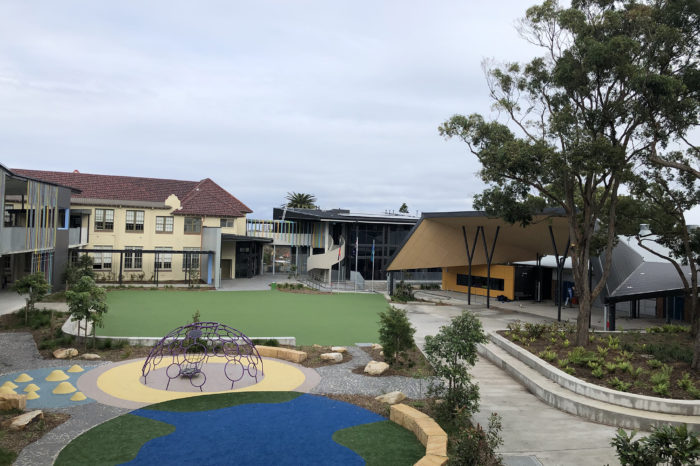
(12, 168), (253, 217)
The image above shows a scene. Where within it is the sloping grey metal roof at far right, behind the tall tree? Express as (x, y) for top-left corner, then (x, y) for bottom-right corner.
(605, 262), (690, 303)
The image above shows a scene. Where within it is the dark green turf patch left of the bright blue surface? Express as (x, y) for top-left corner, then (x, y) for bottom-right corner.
(54, 414), (175, 466)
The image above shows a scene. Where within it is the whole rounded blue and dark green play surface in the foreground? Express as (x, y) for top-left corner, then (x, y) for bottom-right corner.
(55, 392), (425, 465)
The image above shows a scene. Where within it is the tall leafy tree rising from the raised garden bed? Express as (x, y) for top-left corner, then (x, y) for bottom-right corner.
(439, 0), (700, 346)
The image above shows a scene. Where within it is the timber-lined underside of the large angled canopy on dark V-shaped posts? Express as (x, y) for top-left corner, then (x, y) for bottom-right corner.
(387, 209), (569, 270)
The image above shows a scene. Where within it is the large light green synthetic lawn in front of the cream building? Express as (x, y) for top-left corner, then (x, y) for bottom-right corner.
(98, 290), (387, 345)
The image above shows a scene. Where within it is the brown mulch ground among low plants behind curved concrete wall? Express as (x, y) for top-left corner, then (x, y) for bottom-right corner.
(498, 324), (700, 400)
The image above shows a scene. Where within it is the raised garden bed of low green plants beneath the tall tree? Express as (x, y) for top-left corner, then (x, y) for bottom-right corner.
(498, 322), (700, 400)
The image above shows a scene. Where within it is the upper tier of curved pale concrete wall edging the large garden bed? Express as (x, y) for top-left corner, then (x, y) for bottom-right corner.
(488, 332), (700, 416)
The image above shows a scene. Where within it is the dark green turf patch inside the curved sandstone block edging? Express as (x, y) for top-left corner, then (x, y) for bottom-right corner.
(333, 421), (425, 466)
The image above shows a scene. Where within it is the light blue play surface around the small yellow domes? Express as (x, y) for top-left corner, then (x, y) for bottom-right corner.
(0, 364), (95, 409)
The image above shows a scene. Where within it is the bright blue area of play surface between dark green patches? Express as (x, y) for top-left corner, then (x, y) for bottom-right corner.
(127, 394), (385, 466)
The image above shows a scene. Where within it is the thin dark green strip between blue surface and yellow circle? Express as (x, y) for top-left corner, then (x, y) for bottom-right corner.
(142, 392), (301, 413)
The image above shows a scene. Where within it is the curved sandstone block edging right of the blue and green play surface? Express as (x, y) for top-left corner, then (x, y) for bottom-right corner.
(389, 403), (448, 466)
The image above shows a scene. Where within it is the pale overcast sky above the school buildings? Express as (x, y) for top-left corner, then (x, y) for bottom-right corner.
(0, 0), (700, 224)
